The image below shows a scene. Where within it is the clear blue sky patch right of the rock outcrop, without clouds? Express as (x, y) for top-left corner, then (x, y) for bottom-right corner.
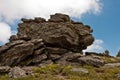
(80, 0), (120, 55)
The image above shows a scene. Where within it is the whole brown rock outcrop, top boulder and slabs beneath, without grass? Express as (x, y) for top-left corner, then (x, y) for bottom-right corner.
(0, 13), (94, 66)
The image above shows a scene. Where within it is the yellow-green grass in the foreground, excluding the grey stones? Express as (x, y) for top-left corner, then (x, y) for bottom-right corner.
(0, 64), (120, 80)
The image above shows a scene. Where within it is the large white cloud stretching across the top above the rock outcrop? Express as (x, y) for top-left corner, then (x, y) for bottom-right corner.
(0, 0), (101, 22)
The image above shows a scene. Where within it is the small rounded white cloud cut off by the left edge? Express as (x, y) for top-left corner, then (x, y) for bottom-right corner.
(0, 22), (12, 43)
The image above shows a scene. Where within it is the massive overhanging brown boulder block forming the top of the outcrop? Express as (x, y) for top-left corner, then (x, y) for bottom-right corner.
(17, 13), (94, 52)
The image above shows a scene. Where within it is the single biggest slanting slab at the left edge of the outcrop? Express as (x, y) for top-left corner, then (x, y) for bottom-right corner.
(0, 43), (34, 66)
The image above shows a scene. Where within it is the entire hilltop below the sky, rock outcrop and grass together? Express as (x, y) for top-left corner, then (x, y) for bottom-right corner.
(0, 13), (120, 80)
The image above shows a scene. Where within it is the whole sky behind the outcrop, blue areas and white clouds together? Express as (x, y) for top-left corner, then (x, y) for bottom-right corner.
(0, 0), (120, 56)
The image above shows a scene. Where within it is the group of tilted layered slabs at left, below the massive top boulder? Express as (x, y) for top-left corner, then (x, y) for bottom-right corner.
(0, 39), (44, 66)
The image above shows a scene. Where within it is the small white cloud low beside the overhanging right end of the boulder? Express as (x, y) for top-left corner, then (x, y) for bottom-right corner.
(84, 39), (104, 52)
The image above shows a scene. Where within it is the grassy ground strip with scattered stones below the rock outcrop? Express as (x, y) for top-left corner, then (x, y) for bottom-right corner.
(0, 55), (120, 80)
